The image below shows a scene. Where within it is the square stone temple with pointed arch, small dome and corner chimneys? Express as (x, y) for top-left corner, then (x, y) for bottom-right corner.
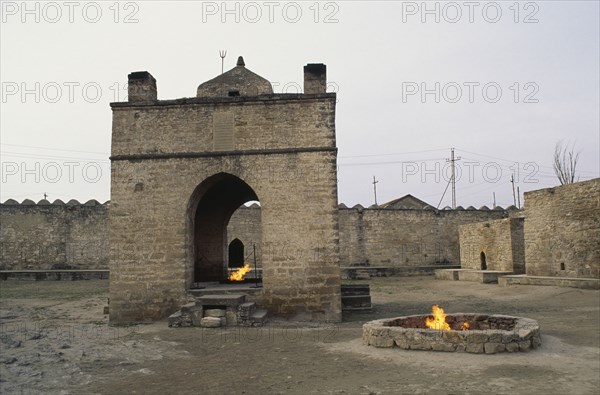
(109, 57), (341, 322)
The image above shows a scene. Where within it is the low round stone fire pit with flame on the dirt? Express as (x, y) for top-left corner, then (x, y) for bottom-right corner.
(363, 313), (541, 354)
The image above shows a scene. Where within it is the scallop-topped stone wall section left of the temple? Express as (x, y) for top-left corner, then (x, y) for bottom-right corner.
(0, 200), (108, 270)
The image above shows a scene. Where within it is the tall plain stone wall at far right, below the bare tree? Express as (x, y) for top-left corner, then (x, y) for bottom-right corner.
(525, 178), (600, 278)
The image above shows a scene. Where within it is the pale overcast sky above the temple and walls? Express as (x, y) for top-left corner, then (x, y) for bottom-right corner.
(0, 1), (600, 207)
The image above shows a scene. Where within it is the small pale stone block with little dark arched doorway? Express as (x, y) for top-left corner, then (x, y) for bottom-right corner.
(459, 218), (525, 274)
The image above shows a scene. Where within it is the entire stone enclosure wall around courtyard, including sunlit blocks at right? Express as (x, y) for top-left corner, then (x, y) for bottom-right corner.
(0, 179), (600, 278)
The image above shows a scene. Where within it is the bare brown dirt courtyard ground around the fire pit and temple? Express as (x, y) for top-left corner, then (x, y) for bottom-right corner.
(0, 277), (600, 394)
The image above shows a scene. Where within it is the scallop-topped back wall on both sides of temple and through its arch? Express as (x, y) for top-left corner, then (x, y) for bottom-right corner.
(0, 202), (508, 270)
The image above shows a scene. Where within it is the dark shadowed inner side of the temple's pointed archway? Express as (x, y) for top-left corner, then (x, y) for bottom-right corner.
(189, 173), (258, 282)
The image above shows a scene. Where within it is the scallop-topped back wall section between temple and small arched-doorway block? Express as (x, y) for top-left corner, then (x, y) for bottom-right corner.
(340, 208), (508, 267)
